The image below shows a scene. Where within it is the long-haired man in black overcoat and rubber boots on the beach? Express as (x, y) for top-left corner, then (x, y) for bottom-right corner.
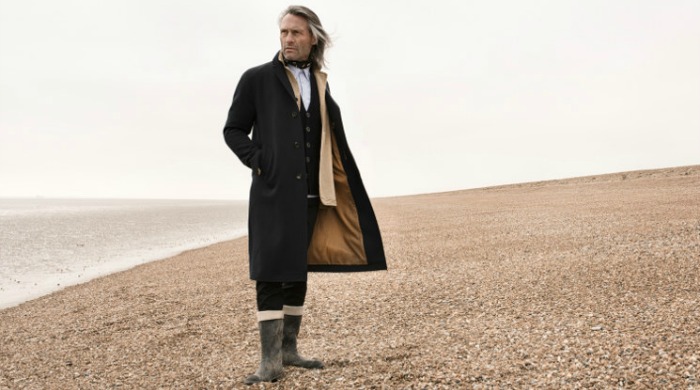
(224, 6), (386, 384)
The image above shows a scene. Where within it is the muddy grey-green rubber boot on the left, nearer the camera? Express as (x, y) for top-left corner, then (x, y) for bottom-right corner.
(244, 320), (284, 385)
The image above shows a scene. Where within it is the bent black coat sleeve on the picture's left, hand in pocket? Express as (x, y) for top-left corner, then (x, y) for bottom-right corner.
(224, 71), (262, 175)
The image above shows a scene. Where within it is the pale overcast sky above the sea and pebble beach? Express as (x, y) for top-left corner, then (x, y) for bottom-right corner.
(0, 0), (700, 199)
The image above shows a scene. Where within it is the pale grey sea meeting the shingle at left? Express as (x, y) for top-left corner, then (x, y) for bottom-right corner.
(0, 198), (248, 309)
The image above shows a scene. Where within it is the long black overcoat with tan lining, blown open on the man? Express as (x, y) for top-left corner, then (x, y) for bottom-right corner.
(224, 53), (386, 282)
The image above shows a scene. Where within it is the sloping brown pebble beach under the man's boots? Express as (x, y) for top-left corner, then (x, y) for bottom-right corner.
(0, 166), (700, 389)
